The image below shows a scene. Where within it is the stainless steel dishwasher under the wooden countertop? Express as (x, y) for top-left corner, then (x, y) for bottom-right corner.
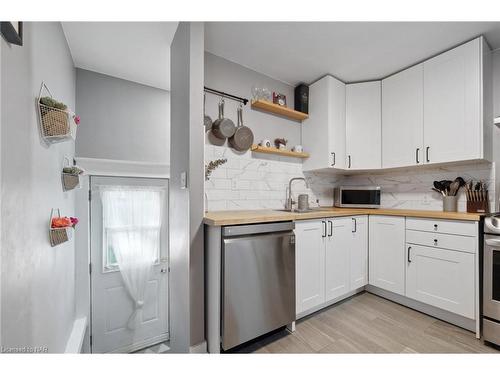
(221, 222), (295, 350)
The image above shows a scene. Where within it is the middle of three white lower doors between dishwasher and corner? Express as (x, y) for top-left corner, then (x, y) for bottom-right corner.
(325, 217), (352, 301)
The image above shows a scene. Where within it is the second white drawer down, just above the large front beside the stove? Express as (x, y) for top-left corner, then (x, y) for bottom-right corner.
(406, 230), (478, 254)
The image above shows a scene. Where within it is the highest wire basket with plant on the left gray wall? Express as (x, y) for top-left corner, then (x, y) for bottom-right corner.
(37, 82), (77, 144)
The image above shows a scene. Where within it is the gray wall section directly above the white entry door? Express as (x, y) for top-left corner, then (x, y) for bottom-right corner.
(76, 69), (170, 164)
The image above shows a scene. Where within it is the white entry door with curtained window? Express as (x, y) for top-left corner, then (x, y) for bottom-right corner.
(91, 177), (169, 353)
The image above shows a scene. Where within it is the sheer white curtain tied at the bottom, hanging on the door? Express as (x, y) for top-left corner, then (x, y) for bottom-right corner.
(101, 186), (163, 329)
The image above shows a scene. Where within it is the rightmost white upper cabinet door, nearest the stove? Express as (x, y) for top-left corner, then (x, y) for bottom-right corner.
(424, 38), (482, 163)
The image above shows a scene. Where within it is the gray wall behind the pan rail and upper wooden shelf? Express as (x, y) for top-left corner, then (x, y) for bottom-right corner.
(205, 52), (301, 147)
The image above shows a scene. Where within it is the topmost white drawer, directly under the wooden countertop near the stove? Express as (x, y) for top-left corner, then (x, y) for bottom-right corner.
(406, 217), (478, 236)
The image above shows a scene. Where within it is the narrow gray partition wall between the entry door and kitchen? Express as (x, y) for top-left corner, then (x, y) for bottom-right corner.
(169, 22), (205, 352)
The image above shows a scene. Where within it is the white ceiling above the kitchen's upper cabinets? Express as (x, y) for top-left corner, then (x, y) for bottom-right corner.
(205, 22), (500, 85)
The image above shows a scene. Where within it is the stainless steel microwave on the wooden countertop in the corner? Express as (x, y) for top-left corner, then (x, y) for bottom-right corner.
(333, 186), (380, 208)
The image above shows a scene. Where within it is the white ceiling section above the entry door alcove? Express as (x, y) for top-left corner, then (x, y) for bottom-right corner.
(62, 22), (178, 90)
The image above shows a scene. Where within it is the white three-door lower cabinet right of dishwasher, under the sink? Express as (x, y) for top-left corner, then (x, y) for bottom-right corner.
(295, 216), (368, 315)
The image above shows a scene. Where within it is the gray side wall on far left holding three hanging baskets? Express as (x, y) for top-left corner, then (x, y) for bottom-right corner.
(0, 22), (75, 352)
